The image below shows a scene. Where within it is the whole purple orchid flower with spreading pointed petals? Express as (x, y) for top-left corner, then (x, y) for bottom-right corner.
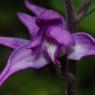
(0, 0), (95, 85)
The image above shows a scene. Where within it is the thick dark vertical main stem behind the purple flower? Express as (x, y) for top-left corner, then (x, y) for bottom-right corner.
(64, 0), (77, 95)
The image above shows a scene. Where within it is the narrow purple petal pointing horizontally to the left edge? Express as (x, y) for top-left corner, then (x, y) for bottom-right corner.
(0, 37), (29, 49)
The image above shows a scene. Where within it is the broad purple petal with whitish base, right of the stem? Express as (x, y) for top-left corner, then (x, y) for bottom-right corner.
(68, 32), (95, 60)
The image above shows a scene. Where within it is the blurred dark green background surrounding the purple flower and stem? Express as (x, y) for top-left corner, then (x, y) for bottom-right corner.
(0, 0), (95, 95)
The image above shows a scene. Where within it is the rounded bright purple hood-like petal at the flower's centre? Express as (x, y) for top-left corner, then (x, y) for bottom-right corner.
(48, 26), (75, 46)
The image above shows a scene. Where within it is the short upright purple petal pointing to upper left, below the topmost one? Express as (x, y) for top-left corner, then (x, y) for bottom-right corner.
(17, 13), (39, 36)
